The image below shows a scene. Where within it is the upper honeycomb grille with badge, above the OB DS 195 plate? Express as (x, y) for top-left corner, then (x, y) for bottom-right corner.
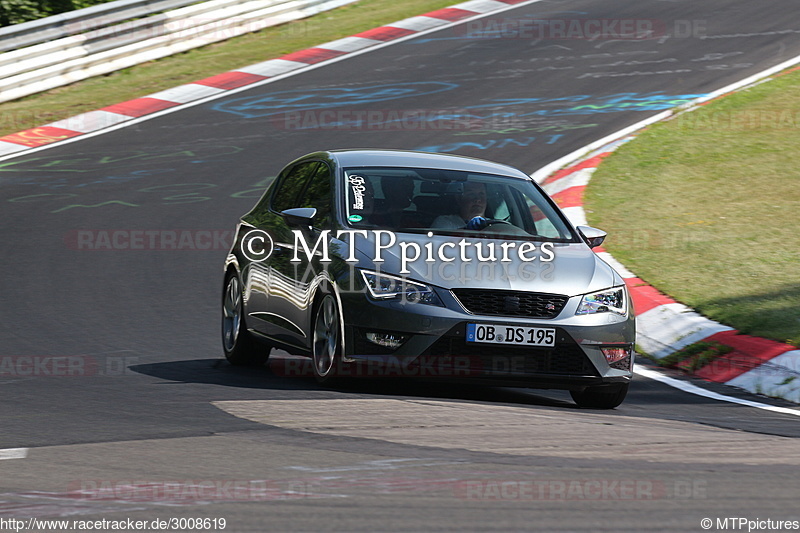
(453, 289), (569, 318)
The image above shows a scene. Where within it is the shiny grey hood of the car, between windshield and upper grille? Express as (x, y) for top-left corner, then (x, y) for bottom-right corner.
(340, 232), (623, 296)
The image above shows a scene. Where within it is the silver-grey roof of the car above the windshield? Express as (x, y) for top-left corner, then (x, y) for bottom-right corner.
(327, 149), (530, 179)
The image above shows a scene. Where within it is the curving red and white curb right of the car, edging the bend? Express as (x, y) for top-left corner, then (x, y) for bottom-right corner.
(533, 57), (800, 403)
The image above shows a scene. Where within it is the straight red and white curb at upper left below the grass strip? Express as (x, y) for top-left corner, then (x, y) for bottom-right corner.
(0, 0), (539, 157)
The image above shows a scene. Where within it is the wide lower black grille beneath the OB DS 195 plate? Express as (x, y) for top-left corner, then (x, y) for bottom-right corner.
(423, 327), (600, 376)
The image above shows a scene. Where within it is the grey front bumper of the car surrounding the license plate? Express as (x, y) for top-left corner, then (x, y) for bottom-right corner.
(341, 286), (635, 390)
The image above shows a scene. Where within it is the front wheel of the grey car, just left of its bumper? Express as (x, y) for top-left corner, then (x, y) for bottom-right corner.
(311, 293), (342, 385)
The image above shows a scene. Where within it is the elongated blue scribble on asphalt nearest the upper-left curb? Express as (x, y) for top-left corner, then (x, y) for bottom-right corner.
(211, 81), (458, 118)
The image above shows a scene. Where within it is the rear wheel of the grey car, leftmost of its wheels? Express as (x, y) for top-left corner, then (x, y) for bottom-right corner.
(222, 272), (271, 366)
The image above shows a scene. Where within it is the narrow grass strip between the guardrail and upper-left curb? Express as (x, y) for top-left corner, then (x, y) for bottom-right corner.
(0, 0), (453, 137)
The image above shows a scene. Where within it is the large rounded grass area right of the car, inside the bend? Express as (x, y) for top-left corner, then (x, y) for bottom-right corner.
(586, 71), (800, 346)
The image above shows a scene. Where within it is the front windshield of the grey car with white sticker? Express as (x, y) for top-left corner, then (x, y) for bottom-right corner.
(344, 168), (575, 242)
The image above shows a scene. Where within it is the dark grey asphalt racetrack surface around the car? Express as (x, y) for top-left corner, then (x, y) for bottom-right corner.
(0, 0), (800, 531)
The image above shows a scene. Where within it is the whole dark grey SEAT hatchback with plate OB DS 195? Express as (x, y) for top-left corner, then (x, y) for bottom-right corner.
(222, 150), (635, 409)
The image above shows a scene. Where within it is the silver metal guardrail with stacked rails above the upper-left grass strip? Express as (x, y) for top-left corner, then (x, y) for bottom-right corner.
(0, 0), (355, 102)
